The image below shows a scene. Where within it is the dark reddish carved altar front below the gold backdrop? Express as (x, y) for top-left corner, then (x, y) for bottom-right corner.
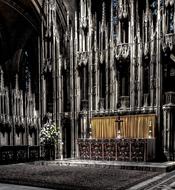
(77, 138), (155, 162)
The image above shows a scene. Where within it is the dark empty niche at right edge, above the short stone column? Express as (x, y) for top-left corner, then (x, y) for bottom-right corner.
(163, 52), (175, 92)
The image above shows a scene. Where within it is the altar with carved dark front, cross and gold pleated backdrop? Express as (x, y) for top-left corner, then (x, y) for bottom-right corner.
(77, 114), (156, 162)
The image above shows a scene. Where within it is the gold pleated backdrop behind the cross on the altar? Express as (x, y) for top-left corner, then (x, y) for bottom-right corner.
(91, 114), (156, 139)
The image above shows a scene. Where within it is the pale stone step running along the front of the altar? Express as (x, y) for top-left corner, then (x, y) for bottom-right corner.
(32, 159), (175, 173)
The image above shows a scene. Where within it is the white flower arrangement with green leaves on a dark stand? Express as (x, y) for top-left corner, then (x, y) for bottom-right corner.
(39, 122), (60, 144)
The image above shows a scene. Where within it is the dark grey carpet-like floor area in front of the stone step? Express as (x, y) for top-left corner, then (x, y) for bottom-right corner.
(0, 164), (160, 190)
